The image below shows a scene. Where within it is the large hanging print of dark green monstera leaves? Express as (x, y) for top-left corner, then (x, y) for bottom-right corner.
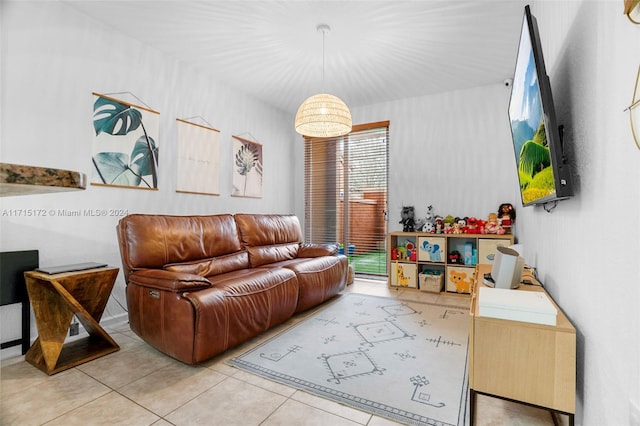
(91, 93), (160, 190)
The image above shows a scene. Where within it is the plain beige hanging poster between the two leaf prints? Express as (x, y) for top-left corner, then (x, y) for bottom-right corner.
(176, 118), (220, 195)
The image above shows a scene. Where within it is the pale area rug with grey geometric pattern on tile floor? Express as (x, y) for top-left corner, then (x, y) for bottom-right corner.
(227, 293), (469, 426)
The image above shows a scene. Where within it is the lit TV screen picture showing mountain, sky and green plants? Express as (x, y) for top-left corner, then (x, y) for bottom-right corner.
(509, 13), (556, 206)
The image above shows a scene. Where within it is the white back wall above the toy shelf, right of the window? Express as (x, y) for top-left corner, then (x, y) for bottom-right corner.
(352, 81), (520, 231)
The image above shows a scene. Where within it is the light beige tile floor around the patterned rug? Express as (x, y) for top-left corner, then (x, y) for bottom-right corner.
(0, 279), (553, 426)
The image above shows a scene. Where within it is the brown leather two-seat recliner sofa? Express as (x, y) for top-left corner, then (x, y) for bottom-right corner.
(117, 214), (348, 364)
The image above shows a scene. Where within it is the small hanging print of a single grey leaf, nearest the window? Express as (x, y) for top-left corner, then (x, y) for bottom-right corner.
(231, 136), (262, 198)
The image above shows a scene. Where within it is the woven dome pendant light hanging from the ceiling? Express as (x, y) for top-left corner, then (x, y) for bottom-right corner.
(295, 24), (352, 138)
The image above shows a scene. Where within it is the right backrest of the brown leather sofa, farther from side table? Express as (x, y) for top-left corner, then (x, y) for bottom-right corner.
(234, 213), (302, 267)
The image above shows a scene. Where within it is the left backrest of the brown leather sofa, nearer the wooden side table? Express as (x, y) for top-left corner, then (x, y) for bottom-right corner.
(117, 214), (249, 281)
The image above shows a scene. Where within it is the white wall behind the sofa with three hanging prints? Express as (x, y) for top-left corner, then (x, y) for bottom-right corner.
(0, 1), (297, 357)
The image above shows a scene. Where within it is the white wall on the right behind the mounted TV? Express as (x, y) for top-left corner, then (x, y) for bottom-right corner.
(518, 1), (640, 425)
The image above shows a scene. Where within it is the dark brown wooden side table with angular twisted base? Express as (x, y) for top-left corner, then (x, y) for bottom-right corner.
(24, 267), (120, 375)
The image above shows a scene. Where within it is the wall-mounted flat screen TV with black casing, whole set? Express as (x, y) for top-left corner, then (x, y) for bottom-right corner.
(509, 6), (573, 206)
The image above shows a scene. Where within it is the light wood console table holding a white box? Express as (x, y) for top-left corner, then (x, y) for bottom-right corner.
(469, 265), (576, 426)
